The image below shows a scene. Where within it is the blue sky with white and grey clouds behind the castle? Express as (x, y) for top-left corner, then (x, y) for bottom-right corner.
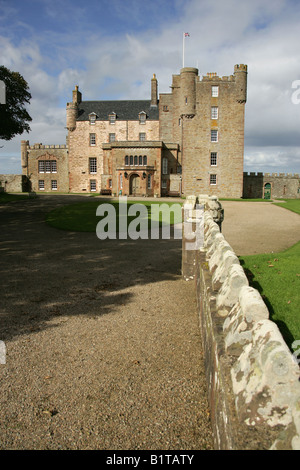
(0, 0), (300, 173)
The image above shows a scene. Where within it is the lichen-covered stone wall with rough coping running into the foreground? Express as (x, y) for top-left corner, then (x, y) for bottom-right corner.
(182, 196), (300, 450)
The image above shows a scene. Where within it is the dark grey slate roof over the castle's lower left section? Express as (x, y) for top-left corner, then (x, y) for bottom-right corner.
(77, 100), (159, 121)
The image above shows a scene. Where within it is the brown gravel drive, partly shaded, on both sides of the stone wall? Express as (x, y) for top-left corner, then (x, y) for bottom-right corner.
(0, 196), (300, 450)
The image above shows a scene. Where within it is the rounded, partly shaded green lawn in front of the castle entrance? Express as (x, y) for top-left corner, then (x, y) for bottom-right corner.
(46, 200), (181, 232)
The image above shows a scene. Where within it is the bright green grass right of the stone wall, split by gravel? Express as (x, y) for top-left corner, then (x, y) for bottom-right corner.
(240, 199), (300, 348)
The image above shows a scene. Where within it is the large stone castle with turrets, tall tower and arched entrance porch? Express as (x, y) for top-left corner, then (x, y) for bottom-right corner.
(21, 65), (247, 198)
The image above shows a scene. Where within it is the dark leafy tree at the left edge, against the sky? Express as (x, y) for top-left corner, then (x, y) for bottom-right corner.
(0, 65), (32, 140)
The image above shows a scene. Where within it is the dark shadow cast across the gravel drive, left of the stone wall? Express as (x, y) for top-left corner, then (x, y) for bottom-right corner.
(0, 196), (181, 341)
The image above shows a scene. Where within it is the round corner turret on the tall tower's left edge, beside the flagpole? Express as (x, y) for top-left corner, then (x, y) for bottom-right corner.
(180, 67), (198, 117)
